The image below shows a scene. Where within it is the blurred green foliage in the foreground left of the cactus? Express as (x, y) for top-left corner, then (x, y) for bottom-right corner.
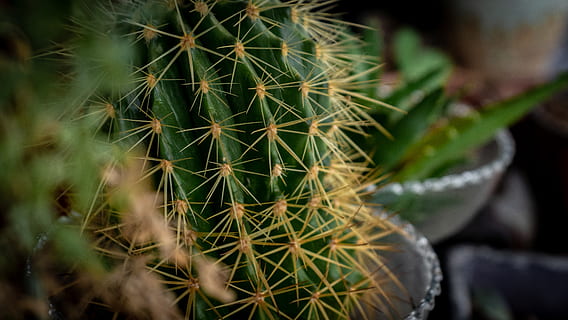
(0, 0), (133, 319)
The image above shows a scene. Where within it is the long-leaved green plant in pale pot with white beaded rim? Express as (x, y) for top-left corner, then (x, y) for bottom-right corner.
(350, 25), (568, 242)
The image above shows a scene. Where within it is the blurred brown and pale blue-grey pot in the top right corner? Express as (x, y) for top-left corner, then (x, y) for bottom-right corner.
(445, 0), (568, 83)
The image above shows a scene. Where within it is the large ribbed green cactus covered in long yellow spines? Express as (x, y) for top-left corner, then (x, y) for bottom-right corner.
(72, 0), (404, 319)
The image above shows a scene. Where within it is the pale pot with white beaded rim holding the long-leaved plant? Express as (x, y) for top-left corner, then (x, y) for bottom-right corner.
(369, 130), (515, 243)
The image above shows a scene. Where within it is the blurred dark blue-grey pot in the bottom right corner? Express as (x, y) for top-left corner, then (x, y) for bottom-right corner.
(446, 245), (568, 320)
